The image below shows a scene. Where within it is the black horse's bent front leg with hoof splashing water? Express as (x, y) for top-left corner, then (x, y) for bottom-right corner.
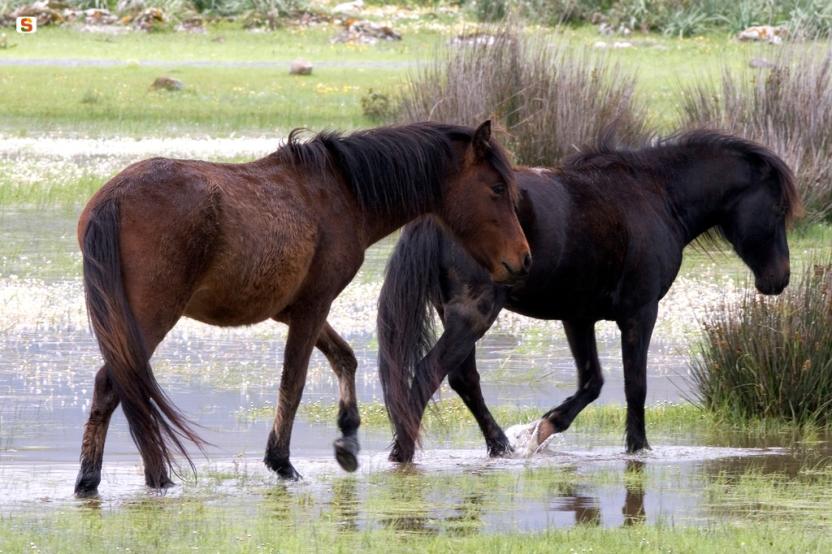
(538, 320), (604, 442)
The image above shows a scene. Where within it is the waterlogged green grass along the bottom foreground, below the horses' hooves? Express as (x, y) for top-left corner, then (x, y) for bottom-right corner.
(0, 462), (832, 553)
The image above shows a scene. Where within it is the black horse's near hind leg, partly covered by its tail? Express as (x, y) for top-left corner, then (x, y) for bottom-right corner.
(390, 282), (505, 462)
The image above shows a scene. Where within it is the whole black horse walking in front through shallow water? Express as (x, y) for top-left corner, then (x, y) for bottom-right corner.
(378, 130), (801, 462)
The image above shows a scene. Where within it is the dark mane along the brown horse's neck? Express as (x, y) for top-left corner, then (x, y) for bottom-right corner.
(272, 122), (513, 214)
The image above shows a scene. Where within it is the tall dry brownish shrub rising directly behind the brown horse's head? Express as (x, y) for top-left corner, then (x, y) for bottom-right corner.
(398, 27), (648, 165)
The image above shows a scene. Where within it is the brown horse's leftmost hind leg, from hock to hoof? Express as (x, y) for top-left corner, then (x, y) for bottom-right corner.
(75, 367), (119, 497)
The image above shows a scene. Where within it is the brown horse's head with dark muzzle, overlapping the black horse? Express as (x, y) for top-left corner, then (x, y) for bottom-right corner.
(437, 121), (532, 283)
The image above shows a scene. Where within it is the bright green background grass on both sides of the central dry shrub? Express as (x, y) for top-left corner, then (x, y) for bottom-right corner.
(0, 24), (796, 135)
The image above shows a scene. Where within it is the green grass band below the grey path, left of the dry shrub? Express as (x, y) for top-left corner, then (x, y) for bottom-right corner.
(0, 62), (397, 135)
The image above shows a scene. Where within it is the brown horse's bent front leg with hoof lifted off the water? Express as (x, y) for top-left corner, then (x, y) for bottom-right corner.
(315, 323), (361, 471)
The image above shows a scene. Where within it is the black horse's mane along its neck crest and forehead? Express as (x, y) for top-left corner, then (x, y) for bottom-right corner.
(561, 129), (802, 221)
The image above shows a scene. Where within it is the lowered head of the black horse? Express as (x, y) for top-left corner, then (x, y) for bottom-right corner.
(720, 140), (801, 294)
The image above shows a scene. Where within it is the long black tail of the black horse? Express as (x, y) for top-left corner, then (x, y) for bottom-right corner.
(378, 217), (443, 448)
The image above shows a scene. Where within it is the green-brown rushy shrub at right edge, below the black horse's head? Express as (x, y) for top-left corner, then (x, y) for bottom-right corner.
(691, 260), (832, 425)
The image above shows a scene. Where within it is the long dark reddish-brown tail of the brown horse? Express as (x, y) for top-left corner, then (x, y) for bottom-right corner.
(82, 199), (204, 478)
